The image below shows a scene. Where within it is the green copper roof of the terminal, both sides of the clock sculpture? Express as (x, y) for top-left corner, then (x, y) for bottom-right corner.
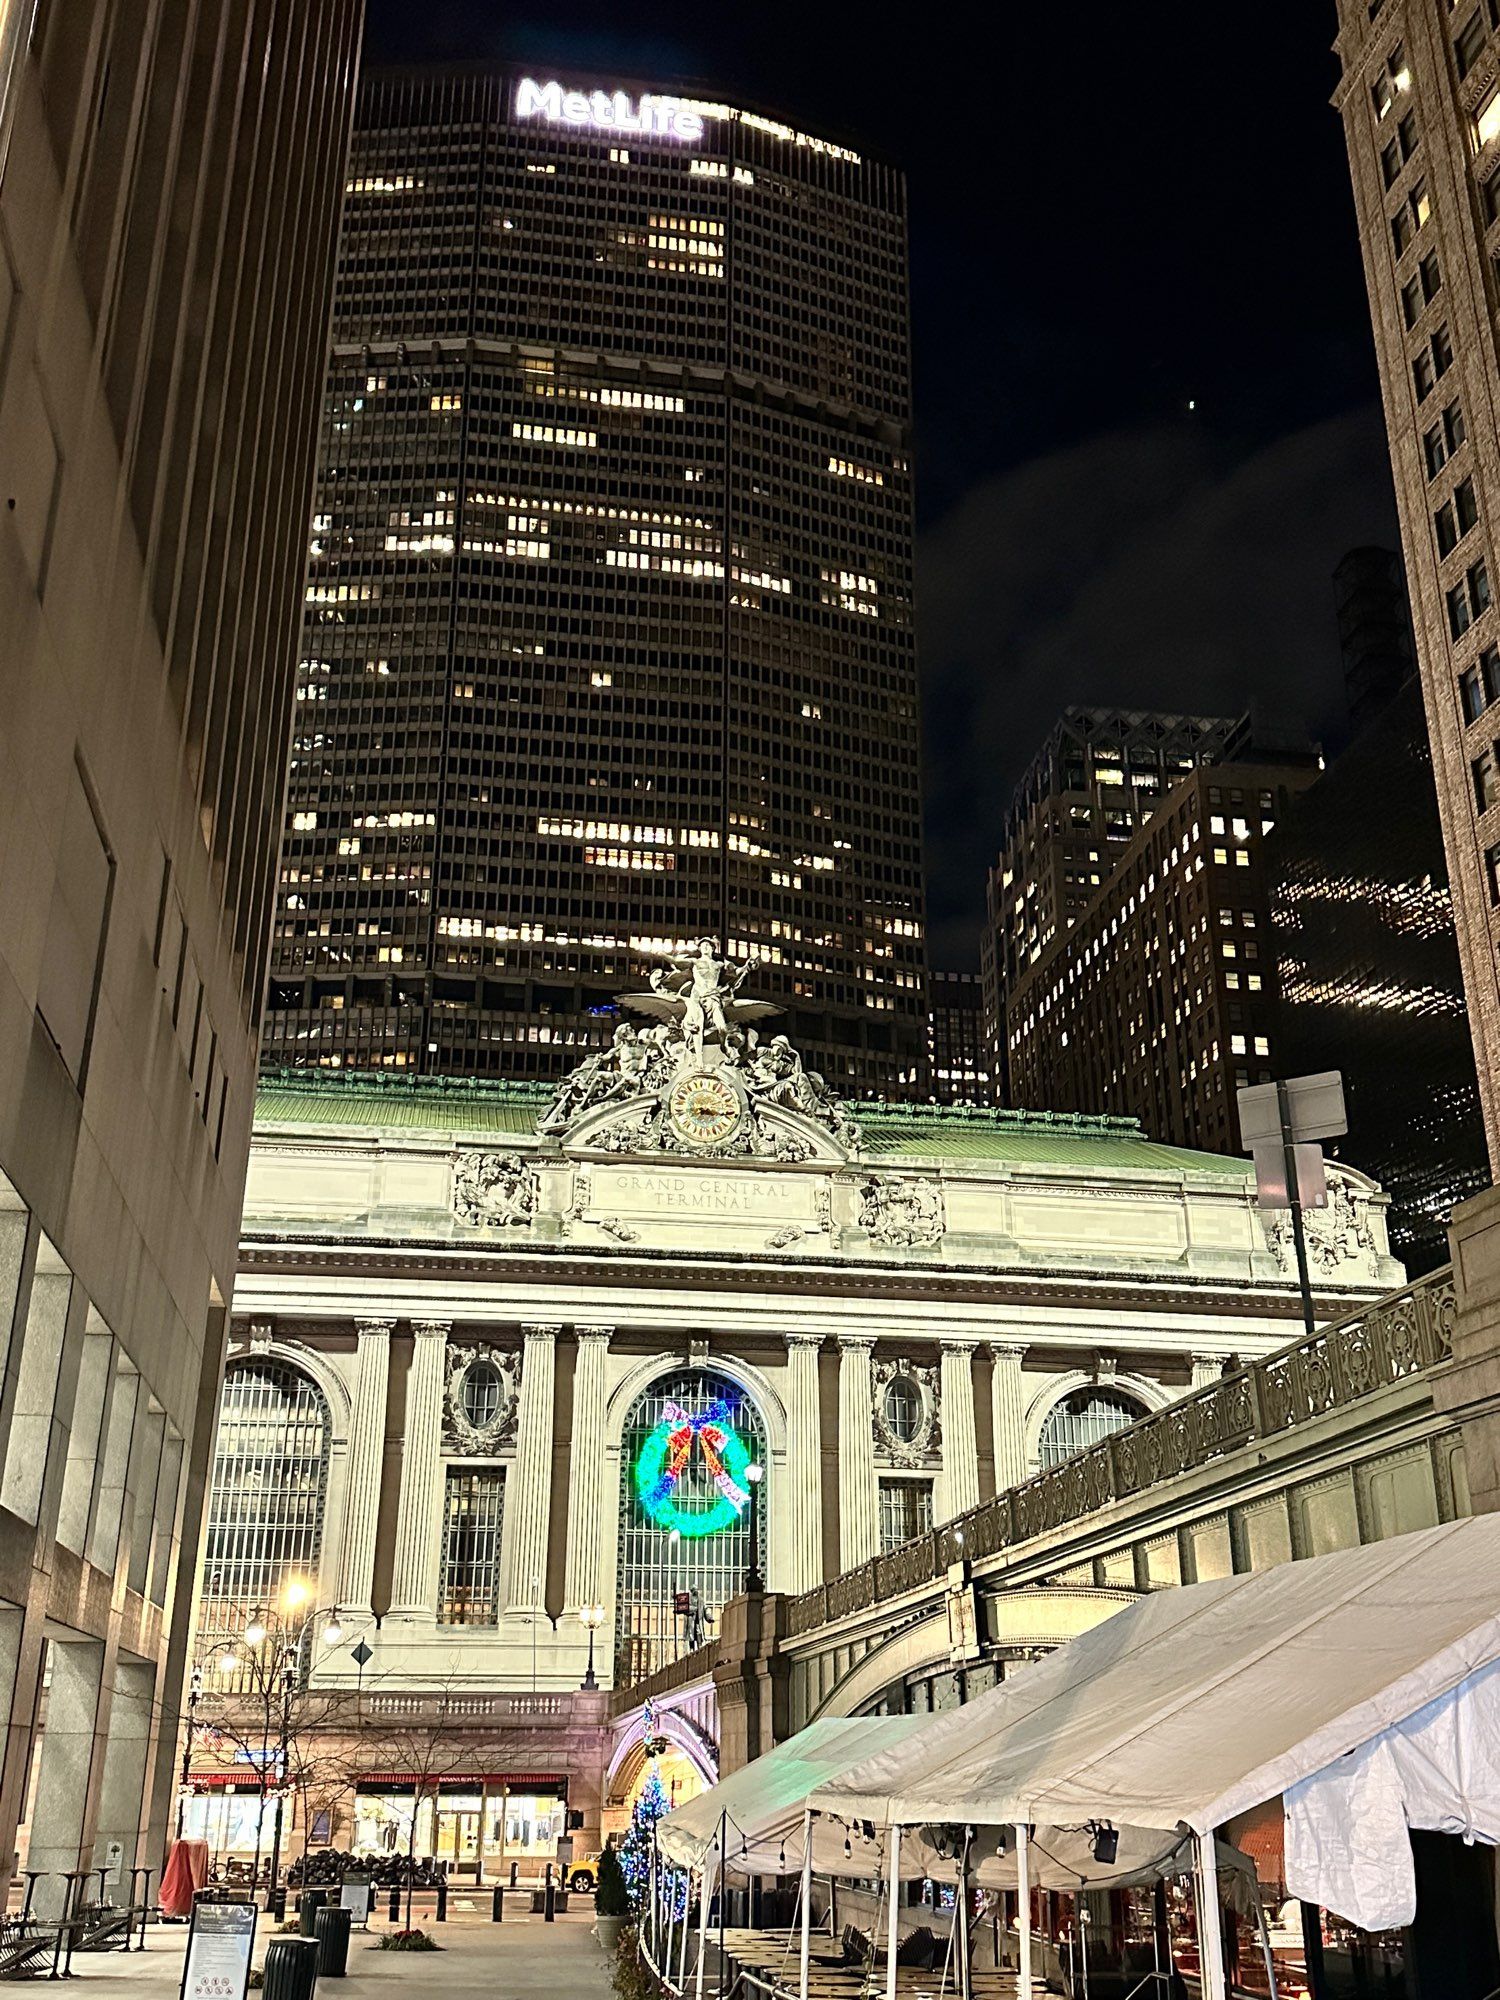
(256, 1070), (1250, 1180)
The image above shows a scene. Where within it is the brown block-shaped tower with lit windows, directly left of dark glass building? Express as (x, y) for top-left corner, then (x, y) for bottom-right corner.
(1006, 744), (1318, 1152)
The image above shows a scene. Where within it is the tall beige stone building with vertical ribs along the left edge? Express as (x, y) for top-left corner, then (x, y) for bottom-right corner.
(0, 0), (360, 1912)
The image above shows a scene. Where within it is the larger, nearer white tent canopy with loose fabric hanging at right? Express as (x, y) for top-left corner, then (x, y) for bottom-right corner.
(812, 1516), (1500, 1922)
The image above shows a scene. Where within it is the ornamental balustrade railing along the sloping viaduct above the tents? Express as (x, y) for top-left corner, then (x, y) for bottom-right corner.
(788, 1268), (1454, 1640)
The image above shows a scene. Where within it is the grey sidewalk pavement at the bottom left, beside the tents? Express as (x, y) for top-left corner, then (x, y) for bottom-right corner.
(53, 1906), (614, 2000)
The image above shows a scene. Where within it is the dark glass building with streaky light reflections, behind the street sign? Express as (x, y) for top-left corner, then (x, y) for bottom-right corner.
(1268, 548), (1490, 1270)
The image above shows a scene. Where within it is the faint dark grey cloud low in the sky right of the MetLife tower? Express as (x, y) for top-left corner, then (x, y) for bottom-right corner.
(918, 408), (1396, 966)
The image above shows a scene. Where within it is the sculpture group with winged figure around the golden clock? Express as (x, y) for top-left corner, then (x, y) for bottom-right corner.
(536, 940), (860, 1162)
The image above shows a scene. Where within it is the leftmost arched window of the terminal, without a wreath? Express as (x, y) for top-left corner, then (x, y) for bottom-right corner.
(198, 1356), (330, 1652)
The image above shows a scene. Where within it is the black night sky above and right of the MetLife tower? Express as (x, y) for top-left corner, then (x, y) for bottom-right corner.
(366, 0), (1396, 966)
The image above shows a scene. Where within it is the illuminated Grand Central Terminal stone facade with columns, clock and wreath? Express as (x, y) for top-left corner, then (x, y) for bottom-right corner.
(184, 946), (1402, 1880)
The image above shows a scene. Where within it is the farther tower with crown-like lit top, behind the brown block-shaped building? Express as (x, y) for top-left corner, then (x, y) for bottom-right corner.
(980, 708), (1246, 1104)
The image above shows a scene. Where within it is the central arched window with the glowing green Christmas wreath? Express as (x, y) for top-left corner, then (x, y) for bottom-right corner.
(614, 1368), (772, 1686)
